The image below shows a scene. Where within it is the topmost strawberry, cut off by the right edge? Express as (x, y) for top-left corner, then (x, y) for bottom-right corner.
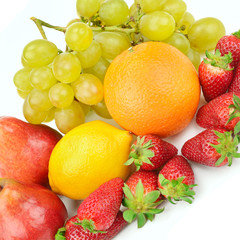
(216, 31), (240, 67)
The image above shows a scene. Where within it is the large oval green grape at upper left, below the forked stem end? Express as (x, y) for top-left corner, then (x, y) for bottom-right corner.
(22, 39), (58, 68)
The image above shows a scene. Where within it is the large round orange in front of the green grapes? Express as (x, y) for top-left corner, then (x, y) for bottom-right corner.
(104, 42), (200, 137)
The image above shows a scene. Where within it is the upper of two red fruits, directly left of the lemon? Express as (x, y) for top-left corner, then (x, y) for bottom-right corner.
(0, 117), (62, 185)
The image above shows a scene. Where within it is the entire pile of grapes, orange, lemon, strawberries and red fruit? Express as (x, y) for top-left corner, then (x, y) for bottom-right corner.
(0, 0), (240, 240)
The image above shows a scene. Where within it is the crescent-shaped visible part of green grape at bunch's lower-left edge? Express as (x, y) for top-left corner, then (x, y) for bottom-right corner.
(23, 97), (48, 124)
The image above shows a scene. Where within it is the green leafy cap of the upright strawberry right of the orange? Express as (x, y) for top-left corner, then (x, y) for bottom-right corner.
(203, 49), (233, 71)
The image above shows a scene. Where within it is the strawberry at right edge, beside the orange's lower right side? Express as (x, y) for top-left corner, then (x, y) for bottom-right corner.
(196, 92), (240, 131)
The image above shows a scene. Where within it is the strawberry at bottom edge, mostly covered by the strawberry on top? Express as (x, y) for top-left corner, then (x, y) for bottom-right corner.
(55, 211), (128, 240)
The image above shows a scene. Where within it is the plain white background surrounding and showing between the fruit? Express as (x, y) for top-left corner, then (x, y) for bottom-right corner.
(0, 0), (240, 240)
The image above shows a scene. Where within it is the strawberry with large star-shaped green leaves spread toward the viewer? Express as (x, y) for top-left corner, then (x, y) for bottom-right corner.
(123, 170), (164, 228)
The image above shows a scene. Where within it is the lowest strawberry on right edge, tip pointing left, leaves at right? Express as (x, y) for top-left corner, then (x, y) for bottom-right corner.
(182, 129), (239, 167)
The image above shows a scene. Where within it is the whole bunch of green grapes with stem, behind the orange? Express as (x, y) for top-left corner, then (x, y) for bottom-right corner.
(11, 0), (225, 134)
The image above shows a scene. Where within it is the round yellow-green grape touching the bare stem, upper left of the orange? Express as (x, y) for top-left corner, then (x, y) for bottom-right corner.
(65, 22), (93, 51)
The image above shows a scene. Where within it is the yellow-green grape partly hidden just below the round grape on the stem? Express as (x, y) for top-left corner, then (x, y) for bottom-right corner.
(76, 40), (102, 68)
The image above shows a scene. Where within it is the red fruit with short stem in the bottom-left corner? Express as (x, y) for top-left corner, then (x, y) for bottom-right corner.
(0, 178), (67, 240)
